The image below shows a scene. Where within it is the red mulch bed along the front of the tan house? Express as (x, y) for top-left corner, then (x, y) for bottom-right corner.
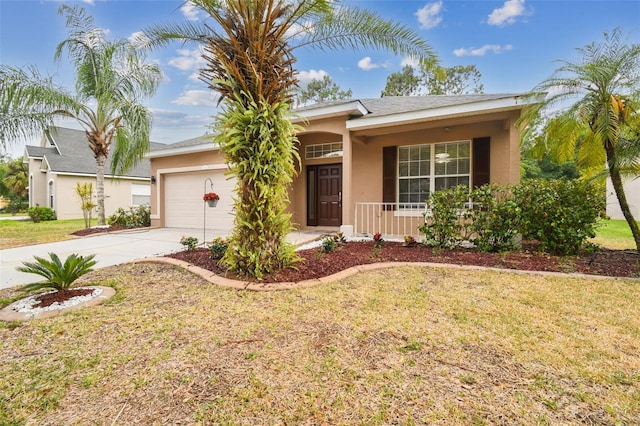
(169, 241), (640, 283)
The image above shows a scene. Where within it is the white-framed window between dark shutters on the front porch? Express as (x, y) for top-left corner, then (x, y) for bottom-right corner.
(398, 141), (471, 207)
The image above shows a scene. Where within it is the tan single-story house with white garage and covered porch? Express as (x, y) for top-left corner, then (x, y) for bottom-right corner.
(148, 94), (540, 235)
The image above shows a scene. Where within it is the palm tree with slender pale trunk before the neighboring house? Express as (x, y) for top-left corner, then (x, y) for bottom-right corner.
(0, 5), (161, 225)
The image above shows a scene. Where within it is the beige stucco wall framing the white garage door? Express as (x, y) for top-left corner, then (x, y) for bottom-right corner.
(150, 147), (226, 227)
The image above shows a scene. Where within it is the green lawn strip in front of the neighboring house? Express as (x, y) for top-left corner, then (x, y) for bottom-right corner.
(0, 219), (97, 249)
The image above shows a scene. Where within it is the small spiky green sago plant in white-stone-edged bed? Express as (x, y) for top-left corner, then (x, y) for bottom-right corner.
(16, 253), (97, 292)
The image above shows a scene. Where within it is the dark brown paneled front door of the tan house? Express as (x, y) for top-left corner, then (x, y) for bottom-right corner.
(307, 164), (342, 226)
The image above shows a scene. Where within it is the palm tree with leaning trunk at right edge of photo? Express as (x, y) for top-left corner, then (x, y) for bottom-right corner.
(520, 28), (640, 252)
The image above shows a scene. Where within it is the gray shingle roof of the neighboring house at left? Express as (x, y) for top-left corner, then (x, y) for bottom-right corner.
(26, 127), (163, 178)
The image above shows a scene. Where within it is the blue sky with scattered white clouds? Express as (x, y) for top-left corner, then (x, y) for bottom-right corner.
(0, 0), (640, 154)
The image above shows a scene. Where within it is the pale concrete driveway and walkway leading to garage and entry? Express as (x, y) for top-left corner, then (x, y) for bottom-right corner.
(0, 228), (321, 289)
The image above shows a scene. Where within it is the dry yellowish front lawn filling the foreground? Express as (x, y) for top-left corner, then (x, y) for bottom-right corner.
(0, 264), (640, 425)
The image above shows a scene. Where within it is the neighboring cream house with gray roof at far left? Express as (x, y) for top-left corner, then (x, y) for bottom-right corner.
(24, 127), (161, 219)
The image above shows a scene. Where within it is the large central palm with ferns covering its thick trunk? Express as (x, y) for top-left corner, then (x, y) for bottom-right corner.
(145, 0), (433, 279)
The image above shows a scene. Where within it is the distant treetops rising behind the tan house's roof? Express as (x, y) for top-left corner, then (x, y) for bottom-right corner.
(381, 61), (484, 96)
